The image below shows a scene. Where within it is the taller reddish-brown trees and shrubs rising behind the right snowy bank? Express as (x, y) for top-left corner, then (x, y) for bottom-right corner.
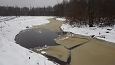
(55, 0), (115, 27)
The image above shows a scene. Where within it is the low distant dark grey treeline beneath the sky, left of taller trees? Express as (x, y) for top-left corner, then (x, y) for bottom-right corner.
(0, 6), (54, 16)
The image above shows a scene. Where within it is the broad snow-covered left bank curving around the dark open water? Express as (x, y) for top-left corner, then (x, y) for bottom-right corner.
(0, 16), (56, 65)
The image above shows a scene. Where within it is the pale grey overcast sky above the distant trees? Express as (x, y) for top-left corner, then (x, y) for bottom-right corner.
(0, 0), (62, 7)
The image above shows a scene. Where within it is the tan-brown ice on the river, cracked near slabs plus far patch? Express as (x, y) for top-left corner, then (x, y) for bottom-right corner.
(34, 19), (115, 65)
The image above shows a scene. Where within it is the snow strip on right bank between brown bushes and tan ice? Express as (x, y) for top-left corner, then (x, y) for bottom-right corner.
(61, 24), (115, 43)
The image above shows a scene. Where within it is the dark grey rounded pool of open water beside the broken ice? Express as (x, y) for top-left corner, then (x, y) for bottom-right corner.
(15, 29), (58, 48)
